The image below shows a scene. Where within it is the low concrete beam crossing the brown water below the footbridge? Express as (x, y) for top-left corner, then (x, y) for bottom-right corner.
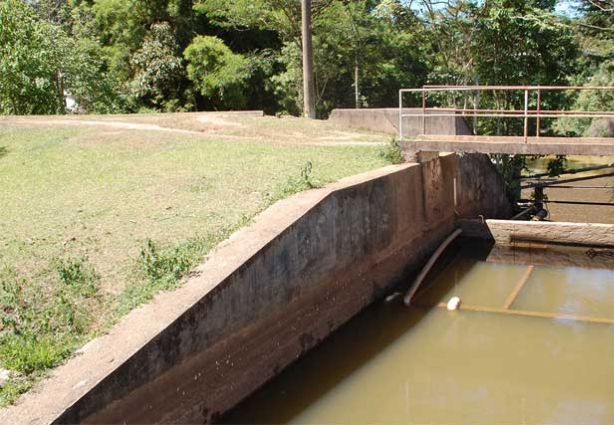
(457, 220), (614, 247)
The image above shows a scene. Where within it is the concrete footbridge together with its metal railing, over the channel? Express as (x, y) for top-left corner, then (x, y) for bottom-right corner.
(398, 86), (614, 156)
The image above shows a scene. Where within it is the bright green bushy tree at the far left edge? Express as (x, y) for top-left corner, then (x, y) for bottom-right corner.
(0, 0), (117, 115)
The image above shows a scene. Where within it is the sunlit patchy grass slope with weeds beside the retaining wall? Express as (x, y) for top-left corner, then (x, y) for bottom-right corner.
(0, 117), (389, 405)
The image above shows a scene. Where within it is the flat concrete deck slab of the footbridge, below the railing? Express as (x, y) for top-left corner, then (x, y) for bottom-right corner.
(410, 134), (614, 156)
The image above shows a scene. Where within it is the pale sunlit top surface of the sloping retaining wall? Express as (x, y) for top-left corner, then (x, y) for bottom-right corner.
(0, 163), (420, 425)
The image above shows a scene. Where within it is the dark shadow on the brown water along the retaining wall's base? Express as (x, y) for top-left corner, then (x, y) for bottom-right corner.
(218, 237), (496, 424)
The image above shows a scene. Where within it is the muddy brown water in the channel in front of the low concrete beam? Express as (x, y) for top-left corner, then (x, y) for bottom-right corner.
(221, 240), (614, 424)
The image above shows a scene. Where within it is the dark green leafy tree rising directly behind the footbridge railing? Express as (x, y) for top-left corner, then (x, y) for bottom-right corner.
(471, 0), (579, 135)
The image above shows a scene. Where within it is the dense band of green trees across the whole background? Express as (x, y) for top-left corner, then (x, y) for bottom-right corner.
(0, 0), (614, 117)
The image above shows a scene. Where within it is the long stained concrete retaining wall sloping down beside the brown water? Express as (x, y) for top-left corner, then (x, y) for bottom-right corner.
(0, 155), (505, 424)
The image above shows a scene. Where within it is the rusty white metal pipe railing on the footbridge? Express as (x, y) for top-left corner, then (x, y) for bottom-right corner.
(399, 86), (614, 143)
